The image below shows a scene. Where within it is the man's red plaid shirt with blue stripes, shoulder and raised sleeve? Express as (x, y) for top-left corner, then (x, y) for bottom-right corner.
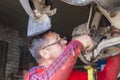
(24, 40), (82, 80)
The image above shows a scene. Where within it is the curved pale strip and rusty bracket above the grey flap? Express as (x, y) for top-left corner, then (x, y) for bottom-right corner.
(19, 0), (57, 19)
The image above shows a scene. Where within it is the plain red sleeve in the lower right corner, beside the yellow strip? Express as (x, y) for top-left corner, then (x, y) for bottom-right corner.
(98, 54), (120, 80)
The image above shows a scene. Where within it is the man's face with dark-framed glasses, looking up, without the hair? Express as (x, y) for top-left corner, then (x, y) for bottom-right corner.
(45, 32), (67, 58)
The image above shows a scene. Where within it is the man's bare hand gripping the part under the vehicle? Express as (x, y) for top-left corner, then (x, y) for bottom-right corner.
(73, 35), (94, 50)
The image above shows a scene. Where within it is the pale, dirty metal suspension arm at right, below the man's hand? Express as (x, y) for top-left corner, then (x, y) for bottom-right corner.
(79, 37), (120, 64)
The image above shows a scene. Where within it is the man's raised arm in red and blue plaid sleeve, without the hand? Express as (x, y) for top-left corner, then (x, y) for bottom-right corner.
(46, 40), (82, 80)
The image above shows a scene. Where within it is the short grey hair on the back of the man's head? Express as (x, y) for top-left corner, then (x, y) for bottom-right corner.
(29, 38), (45, 63)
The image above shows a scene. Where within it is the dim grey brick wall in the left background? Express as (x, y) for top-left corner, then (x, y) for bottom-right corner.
(0, 24), (28, 80)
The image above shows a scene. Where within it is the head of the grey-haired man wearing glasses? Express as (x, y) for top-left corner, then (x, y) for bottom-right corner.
(30, 32), (67, 63)
